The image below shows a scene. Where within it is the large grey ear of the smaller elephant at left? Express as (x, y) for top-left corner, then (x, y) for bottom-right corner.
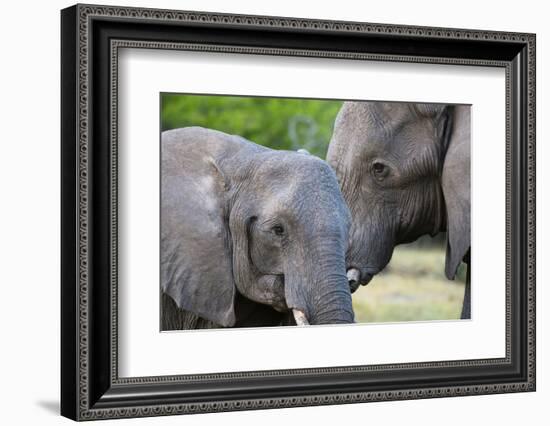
(160, 129), (236, 327)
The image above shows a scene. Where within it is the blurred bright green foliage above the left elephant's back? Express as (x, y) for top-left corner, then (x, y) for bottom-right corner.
(161, 93), (342, 158)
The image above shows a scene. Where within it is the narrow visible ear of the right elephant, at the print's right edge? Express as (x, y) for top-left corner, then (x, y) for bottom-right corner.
(441, 105), (471, 279)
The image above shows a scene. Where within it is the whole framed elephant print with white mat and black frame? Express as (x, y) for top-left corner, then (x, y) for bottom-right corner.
(61, 5), (535, 420)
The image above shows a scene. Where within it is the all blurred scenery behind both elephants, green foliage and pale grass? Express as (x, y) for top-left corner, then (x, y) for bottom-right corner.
(160, 93), (466, 322)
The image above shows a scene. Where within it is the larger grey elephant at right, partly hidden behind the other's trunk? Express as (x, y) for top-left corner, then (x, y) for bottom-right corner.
(327, 102), (470, 318)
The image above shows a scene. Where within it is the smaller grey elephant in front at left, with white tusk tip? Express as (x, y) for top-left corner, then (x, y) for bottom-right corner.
(161, 127), (354, 328)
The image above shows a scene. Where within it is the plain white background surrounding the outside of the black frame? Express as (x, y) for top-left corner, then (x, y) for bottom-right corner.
(0, 0), (550, 426)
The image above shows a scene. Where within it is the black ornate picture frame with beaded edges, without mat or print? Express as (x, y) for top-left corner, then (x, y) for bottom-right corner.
(61, 5), (535, 420)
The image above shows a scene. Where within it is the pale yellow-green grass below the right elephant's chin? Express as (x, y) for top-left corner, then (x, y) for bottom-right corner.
(353, 246), (465, 322)
